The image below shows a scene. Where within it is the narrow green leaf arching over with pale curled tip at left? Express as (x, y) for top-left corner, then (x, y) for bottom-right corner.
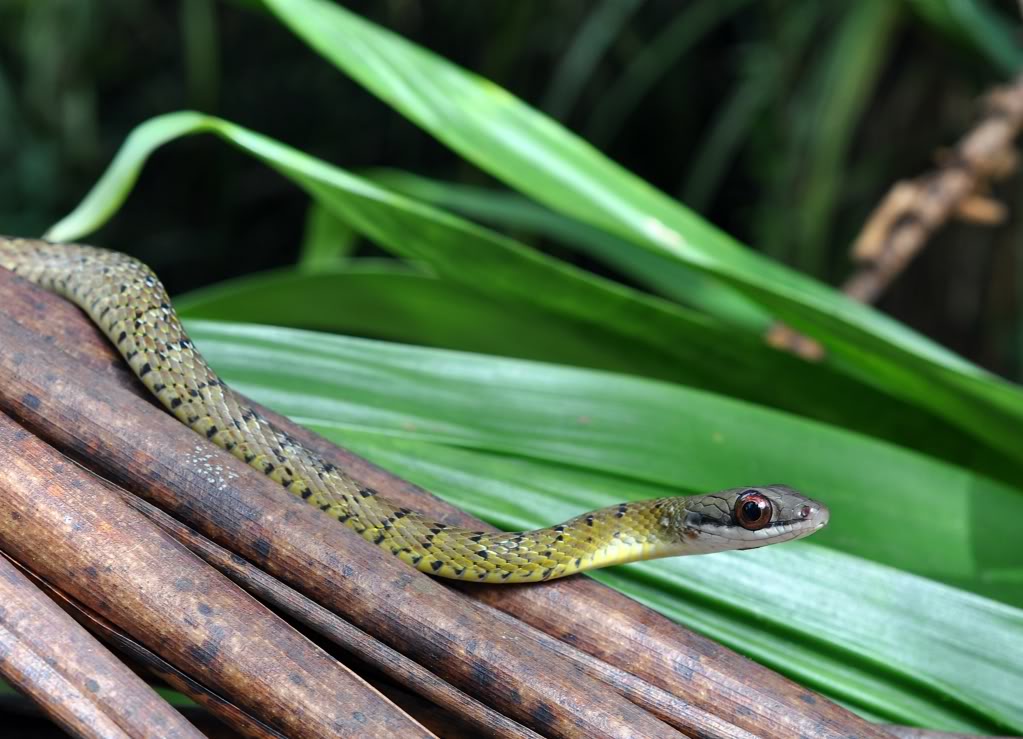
(49, 113), (1006, 478)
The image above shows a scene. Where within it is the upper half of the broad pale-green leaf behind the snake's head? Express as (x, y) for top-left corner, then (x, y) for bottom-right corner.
(184, 323), (1023, 605)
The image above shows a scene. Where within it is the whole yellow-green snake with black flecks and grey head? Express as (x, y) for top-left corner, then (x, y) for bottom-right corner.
(0, 236), (829, 583)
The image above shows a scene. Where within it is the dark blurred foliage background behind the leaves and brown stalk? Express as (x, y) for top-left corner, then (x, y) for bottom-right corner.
(0, 0), (1023, 380)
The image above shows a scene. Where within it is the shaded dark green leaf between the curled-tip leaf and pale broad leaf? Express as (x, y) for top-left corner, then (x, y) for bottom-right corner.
(174, 260), (683, 374)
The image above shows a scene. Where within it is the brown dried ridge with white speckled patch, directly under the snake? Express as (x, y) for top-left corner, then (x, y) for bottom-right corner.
(0, 266), (679, 737)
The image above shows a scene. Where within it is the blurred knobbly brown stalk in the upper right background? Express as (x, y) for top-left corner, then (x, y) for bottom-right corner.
(767, 75), (1023, 360)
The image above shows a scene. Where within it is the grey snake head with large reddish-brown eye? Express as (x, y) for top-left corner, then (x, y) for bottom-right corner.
(664, 485), (829, 554)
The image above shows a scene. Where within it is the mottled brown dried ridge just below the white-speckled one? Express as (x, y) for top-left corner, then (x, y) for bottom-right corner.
(0, 415), (432, 737)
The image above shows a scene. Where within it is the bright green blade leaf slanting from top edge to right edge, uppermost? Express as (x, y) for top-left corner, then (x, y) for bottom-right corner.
(257, 0), (1023, 460)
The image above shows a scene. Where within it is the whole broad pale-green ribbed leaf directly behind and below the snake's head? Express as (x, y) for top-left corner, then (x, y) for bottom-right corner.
(188, 321), (1023, 731)
